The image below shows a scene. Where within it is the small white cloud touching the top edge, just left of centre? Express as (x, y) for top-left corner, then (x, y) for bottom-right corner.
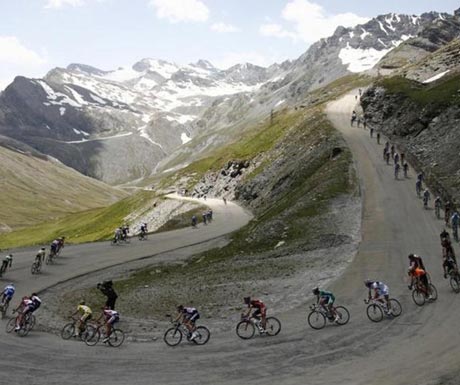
(149, 0), (209, 23)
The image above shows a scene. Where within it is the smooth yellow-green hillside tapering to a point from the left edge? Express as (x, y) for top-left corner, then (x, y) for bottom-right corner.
(0, 147), (127, 232)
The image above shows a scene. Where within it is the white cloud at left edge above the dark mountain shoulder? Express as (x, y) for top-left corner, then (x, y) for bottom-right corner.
(0, 36), (48, 89)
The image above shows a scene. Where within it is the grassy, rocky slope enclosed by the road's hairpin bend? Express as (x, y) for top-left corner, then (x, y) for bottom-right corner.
(62, 106), (357, 317)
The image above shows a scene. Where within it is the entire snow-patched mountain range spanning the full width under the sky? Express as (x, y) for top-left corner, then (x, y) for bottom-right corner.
(0, 7), (460, 183)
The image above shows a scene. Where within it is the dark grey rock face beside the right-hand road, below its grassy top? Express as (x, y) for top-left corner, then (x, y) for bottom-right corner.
(361, 87), (460, 204)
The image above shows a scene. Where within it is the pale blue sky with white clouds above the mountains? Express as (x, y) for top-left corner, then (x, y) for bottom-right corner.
(0, 0), (460, 90)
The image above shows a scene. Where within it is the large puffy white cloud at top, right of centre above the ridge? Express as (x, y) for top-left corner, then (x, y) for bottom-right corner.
(259, 0), (369, 43)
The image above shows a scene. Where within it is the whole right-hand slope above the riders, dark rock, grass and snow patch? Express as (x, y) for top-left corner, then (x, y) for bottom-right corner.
(361, 52), (460, 202)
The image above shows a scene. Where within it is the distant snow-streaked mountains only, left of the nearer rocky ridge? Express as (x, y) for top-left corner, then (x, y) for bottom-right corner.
(0, 59), (269, 183)
